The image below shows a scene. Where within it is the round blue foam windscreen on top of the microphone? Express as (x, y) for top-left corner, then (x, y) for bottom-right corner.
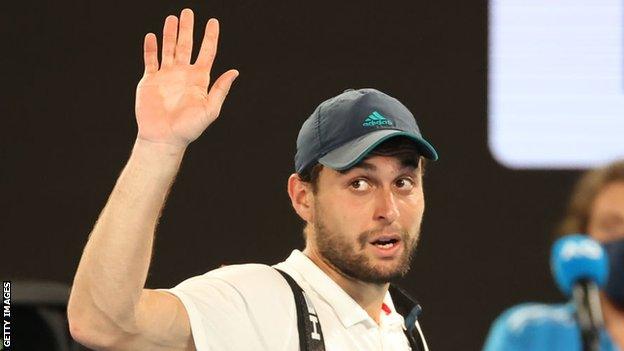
(550, 234), (609, 296)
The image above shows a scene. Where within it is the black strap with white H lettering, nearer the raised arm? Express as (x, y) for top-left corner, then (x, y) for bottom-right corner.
(275, 268), (325, 351)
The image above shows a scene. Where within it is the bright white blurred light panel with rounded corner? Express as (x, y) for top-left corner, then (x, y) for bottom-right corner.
(488, 0), (624, 169)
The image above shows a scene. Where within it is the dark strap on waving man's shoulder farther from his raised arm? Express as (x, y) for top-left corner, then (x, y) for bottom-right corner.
(388, 284), (429, 351)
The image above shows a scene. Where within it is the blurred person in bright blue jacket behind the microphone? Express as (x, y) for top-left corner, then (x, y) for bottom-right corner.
(484, 160), (624, 351)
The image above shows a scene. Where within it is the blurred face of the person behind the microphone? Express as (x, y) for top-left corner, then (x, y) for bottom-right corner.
(588, 181), (624, 242)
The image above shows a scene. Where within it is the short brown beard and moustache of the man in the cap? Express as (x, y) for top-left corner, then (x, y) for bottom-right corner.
(314, 202), (420, 284)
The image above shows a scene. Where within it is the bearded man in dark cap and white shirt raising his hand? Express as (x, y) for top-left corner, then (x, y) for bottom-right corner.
(68, 9), (437, 350)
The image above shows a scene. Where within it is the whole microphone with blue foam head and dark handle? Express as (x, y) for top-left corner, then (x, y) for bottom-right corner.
(550, 234), (609, 351)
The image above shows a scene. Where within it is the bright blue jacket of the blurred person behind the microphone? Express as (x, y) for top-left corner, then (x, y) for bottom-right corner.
(483, 303), (619, 351)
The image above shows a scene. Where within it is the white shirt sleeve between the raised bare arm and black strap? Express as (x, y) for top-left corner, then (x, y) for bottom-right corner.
(162, 265), (298, 351)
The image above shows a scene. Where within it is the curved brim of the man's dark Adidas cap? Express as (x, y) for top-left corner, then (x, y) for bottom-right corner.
(319, 129), (438, 171)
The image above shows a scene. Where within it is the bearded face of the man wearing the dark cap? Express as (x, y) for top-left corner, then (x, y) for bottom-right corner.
(309, 156), (425, 284)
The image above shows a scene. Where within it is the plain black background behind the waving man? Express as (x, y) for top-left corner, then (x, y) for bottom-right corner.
(0, 0), (578, 350)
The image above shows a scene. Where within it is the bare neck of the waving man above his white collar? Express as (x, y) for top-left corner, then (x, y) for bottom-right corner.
(303, 247), (389, 324)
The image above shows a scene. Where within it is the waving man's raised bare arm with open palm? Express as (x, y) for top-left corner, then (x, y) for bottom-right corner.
(68, 9), (238, 350)
